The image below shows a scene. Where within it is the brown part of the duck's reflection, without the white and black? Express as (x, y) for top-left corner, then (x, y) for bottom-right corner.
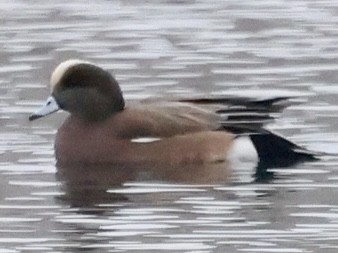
(57, 162), (231, 207)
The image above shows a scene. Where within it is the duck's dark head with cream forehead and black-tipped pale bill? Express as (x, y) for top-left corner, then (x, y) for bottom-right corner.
(29, 60), (124, 121)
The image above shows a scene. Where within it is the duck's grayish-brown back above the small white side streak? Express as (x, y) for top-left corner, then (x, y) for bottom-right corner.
(111, 102), (221, 138)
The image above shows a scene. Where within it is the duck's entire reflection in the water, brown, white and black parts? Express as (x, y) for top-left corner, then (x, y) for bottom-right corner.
(57, 152), (315, 207)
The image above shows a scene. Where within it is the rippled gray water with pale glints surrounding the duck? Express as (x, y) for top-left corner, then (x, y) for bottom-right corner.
(0, 0), (338, 253)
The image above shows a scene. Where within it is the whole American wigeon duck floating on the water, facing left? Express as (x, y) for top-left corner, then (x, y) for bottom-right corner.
(30, 60), (314, 172)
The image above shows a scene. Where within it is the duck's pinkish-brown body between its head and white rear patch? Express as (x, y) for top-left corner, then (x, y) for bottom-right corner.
(55, 104), (234, 166)
